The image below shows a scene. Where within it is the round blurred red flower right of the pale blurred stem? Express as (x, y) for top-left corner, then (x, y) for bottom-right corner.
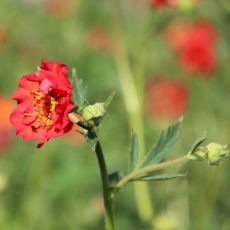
(146, 76), (188, 118)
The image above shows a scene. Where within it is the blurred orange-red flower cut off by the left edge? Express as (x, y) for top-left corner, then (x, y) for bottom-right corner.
(0, 96), (13, 150)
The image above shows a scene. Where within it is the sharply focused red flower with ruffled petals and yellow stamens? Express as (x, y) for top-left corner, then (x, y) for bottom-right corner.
(10, 61), (73, 148)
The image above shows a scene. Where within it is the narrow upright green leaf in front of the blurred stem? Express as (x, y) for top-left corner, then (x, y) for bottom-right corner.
(128, 130), (139, 172)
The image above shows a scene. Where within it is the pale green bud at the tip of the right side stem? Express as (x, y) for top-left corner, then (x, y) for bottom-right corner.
(206, 143), (229, 165)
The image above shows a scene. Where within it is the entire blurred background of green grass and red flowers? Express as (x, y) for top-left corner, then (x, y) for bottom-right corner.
(0, 0), (230, 230)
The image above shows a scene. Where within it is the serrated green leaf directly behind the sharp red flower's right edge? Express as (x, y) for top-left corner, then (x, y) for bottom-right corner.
(70, 69), (87, 105)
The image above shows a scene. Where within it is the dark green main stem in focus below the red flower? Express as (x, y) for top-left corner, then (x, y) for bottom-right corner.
(95, 134), (114, 230)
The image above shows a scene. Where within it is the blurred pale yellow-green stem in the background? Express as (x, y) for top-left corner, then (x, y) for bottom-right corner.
(112, 0), (153, 221)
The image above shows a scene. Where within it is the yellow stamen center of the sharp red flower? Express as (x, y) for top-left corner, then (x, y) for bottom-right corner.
(33, 92), (58, 128)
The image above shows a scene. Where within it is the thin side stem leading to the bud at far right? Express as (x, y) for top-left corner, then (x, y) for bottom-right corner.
(116, 156), (189, 188)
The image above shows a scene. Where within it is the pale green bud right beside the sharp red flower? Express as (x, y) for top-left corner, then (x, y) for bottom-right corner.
(82, 102), (106, 126)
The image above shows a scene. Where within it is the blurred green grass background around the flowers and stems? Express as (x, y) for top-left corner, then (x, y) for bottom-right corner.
(0, 0), (230, 230)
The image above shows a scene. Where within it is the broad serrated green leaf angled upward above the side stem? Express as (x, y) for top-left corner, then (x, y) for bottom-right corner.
(142, 119), (182, 168)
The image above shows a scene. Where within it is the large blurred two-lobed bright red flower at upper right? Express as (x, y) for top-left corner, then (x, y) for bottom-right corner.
(165, 19), (217, 74)
